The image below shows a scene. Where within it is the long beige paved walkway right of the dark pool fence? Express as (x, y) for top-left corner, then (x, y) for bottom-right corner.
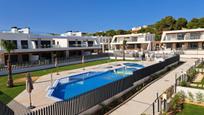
(111, 59), (195, 115)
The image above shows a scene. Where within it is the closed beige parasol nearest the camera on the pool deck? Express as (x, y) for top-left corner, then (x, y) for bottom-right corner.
(26, 72), (35, 109)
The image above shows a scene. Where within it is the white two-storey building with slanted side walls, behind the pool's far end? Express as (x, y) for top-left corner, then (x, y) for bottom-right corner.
(111, 33), (155, 51)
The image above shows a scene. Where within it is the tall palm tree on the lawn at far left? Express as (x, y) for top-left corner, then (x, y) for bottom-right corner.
(0, 40), (16, 87)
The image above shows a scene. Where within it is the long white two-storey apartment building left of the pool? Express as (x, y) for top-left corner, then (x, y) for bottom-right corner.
(0, 28), (101, 64)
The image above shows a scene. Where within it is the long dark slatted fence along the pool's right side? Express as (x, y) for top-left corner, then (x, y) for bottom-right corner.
(24, 55), (180, 115)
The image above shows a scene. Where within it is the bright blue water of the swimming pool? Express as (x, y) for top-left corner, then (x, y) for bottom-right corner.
(50, 63), (144, 100)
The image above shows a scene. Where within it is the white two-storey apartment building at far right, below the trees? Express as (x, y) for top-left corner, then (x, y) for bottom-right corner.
(161, 28), (204, 50)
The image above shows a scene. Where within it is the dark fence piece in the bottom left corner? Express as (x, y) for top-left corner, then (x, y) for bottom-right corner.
(0, 102), (14, 115)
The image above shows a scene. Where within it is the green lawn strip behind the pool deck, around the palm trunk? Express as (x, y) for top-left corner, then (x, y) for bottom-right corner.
(0, 60), (118, 104)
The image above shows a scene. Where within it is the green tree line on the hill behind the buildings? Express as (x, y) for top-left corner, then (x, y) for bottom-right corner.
(93, 16), (204, 41)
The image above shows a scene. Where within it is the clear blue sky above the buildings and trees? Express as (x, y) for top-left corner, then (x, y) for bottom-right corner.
(0, 0), (204, 33)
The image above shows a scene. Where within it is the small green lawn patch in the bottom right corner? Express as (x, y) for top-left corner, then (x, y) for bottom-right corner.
(176, 104), (204, 115)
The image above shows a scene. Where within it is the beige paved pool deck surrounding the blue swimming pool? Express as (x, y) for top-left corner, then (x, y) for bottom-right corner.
(8, 61), (155, 115)
